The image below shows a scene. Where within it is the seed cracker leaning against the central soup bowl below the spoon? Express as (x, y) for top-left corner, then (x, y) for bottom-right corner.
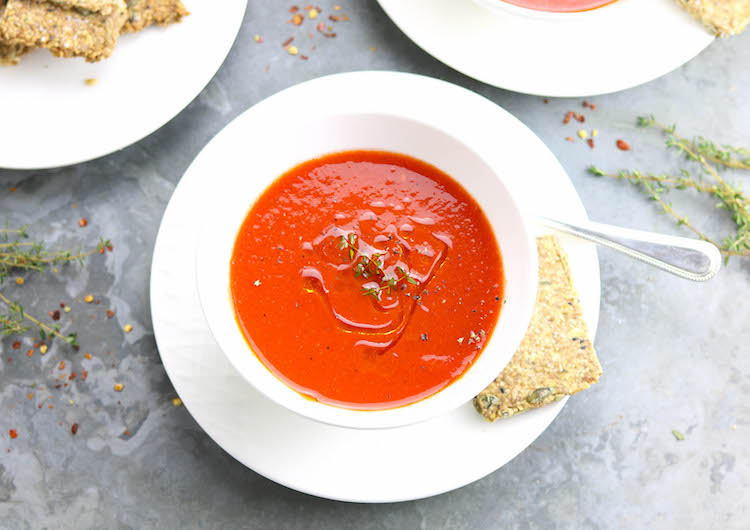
(474, 236), (602, 421)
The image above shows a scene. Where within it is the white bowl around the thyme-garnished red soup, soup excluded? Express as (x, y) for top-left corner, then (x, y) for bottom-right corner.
(196, 101), (537, 428)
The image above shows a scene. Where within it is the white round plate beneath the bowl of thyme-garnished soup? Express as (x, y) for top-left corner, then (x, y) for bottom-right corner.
(151, 72), (599, 502)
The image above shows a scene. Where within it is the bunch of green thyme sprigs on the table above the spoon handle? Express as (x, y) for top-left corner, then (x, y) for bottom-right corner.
(588, 116), (750, 260)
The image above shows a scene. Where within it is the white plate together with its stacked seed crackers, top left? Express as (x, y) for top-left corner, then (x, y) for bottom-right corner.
(0, 0), (247, 169)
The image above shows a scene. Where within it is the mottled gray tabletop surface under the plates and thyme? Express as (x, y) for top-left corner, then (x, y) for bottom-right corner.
(0, 0), (750, 529)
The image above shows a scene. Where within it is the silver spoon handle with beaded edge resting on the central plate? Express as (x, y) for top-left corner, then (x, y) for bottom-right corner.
(537, 217), (721, 282)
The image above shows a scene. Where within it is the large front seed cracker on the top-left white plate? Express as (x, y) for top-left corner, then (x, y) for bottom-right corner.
(0, 0), (128, 62)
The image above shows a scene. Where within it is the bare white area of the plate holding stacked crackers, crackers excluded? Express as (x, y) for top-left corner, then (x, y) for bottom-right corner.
(0, 0), (247, 169)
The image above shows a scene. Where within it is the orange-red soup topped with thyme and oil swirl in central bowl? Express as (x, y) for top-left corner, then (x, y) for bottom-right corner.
(230, 151), (503, 410)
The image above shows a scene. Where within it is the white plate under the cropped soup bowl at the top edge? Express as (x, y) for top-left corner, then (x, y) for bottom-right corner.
(378, 0), (713, 97)
